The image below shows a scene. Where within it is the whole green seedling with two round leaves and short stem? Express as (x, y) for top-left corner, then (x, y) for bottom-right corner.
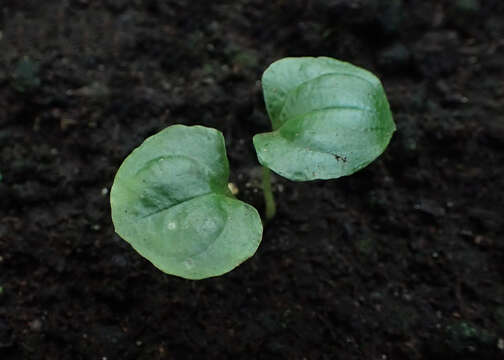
(110, 57), (395, 279)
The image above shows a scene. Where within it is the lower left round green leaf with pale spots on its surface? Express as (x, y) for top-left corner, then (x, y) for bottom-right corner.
(110, 125), (262, 279)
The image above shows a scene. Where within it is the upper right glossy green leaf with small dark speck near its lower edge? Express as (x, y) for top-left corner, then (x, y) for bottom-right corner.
(254, 57), (395, 181)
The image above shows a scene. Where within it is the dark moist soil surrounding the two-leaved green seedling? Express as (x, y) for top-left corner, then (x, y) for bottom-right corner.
(0, 0), (504, 360)
